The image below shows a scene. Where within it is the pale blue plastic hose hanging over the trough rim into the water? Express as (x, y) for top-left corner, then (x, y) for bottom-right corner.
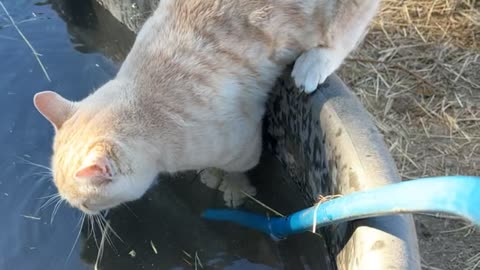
(203, 176), (480, 238)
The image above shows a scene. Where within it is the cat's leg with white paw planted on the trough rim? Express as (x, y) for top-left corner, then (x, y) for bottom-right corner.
(292, 0), (379, 93)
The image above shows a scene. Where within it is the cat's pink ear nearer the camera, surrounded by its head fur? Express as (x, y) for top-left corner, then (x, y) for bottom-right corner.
(74, 153), (113, 184)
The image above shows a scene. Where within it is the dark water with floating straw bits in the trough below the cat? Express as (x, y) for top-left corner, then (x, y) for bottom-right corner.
(0, 0), (326, 270)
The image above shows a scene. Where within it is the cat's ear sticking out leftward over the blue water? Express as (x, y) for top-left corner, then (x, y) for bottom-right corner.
(33, 91), (75, 130)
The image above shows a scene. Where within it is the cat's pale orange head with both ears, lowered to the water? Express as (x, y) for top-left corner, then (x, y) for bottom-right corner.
(34, 91), (157, 214)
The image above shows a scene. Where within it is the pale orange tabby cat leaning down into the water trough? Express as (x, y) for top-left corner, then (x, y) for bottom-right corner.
(34, 0), (378, 214)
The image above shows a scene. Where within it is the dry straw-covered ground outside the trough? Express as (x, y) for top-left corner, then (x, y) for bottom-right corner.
(339, 0), (480, 270)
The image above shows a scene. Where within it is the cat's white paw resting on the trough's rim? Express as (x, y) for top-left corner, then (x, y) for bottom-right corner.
(292, 48), (338, 94)
